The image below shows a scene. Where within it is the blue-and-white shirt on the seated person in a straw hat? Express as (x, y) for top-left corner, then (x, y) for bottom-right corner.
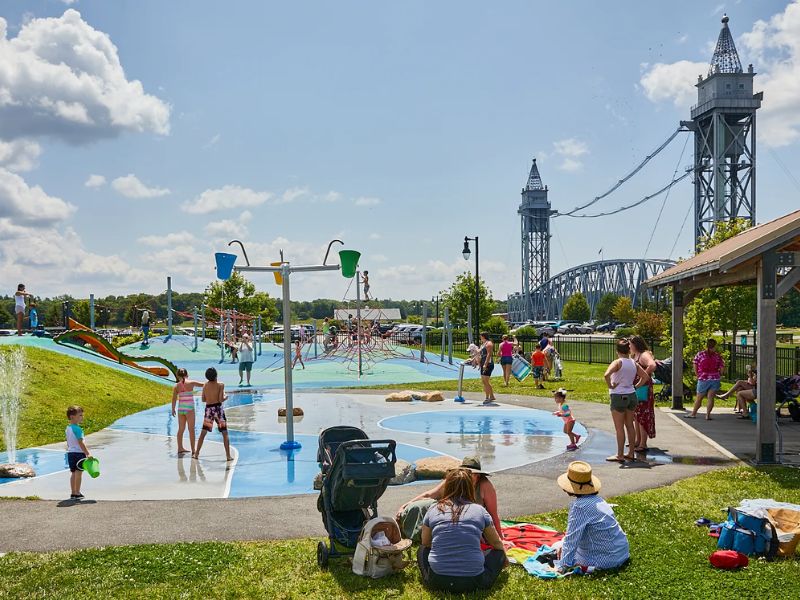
(558, 496), (630, 569)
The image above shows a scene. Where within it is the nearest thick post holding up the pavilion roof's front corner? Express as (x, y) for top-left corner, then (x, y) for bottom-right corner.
(756, 252), (778, 464)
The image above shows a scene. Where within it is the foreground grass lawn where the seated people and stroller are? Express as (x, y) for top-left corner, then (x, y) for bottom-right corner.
(0, 467), (800, 600)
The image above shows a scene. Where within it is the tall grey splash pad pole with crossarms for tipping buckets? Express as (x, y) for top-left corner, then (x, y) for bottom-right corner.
(228, 240), (346, 450)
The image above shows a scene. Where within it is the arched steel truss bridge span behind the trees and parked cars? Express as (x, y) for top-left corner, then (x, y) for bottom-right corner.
(508, 258), (675, 323)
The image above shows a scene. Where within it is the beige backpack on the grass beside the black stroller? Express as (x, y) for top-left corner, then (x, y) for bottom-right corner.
(353, 517), (411, 579)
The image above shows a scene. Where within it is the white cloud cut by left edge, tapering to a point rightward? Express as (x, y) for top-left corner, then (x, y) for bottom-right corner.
(0, 168), (75, 227)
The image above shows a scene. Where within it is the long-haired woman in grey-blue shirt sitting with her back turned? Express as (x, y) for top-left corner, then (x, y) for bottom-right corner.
(417, 468), (508, 593)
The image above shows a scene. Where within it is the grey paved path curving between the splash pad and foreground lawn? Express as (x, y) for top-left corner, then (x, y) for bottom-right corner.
(0, 390), (731, 552)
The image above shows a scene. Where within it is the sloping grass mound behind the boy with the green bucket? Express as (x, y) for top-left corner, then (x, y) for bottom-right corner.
(0, 346), (172, 450)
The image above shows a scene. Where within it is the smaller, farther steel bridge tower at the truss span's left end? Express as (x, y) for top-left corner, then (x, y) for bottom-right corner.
(517, 158), (553, 319)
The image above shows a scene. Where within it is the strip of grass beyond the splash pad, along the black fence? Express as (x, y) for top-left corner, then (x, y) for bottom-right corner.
(373, 362), (735, 407)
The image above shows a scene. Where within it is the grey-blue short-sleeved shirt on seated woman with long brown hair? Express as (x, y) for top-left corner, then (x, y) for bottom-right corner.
(422, 504), (492, 577)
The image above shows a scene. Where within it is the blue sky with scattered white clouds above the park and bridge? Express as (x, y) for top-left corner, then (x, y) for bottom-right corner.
(0, 0), (800, 300)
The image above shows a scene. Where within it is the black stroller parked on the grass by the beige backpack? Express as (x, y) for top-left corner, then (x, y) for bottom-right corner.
(317, 426), (397, 568)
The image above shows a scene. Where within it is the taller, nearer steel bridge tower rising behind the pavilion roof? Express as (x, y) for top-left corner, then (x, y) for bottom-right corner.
(682, 15), (763, 247)
